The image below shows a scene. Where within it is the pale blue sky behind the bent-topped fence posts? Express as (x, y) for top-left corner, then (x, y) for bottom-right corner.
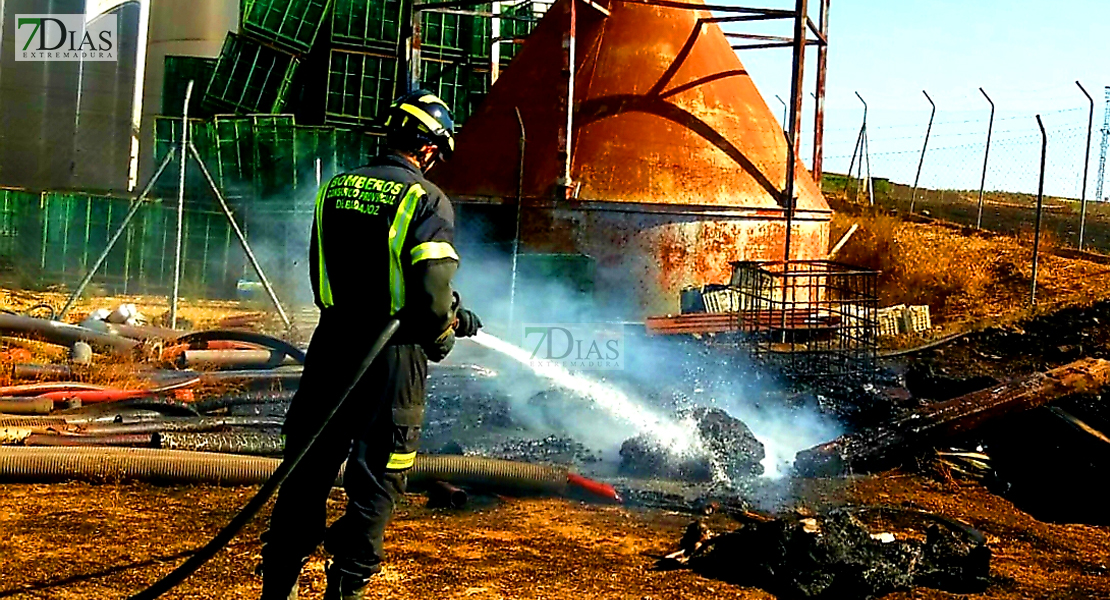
(726, 0), (1110, 197)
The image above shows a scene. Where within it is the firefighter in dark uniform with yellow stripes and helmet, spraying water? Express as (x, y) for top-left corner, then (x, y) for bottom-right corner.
(262, 90), (482, 600)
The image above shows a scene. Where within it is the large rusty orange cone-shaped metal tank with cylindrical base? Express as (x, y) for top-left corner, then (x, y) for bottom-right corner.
(432, 0), (831, 318)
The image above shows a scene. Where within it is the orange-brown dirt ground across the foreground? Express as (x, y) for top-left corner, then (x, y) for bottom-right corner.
(0, 472), (1110, 600)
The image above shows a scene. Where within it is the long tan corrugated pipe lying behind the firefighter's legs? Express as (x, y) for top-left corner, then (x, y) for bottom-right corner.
(0, 445), (569, 495)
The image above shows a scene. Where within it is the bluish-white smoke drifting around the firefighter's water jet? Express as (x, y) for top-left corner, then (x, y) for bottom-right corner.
(452, 238), (840, 478)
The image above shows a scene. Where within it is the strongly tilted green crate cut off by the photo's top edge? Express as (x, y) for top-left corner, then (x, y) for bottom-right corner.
(242, 0), (331, 54)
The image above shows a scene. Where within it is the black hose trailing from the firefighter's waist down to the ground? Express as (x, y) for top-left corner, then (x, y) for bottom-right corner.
(130, 318), (401, 600)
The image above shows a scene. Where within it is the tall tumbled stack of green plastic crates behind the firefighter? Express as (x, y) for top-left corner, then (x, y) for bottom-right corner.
(147, 0), (546, 292)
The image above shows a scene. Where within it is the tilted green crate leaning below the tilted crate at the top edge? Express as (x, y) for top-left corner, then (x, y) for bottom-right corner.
(204, 33), (299, 113)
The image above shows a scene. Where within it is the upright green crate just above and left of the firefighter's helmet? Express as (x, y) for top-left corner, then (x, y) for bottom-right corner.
(324, 50), (397, 126)
